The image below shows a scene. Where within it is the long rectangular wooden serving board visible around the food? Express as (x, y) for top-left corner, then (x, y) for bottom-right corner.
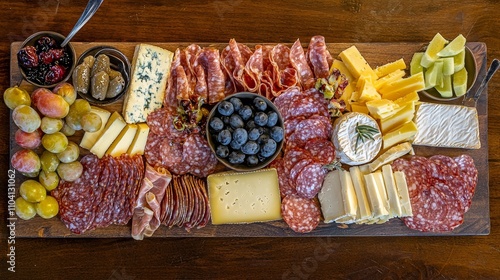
(10, 42), (490, 238)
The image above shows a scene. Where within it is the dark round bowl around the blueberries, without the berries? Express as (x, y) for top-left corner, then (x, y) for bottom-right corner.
(206, 92), (285, 171)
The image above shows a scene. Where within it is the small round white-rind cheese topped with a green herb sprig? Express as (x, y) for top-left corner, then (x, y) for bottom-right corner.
(332, 113), (382, 165)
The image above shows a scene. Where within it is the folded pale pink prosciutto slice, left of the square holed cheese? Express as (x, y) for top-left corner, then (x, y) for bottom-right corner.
(132, 164), (172, 240)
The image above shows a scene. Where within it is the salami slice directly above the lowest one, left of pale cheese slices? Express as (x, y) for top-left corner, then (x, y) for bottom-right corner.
(296, 163), (327, 198)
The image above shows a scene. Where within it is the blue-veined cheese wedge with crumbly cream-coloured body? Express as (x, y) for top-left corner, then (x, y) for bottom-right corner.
(123, 44), (174, 123)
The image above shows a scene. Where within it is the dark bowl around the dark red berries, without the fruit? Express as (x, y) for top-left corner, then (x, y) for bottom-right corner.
(18, 31), (76, 88)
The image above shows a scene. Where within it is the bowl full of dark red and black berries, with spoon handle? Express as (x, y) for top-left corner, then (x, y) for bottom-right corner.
(17, 31), (76, 88)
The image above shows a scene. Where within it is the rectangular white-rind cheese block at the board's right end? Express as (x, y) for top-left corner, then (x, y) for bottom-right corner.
(413, 102), (481, 149)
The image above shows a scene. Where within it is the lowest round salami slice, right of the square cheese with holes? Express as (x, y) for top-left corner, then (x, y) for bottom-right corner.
(281, 195), (321, 233)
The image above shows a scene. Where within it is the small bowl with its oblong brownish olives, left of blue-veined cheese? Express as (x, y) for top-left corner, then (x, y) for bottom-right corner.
(73, 46), (130, 105)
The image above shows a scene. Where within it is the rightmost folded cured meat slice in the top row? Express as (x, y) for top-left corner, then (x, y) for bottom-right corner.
(307, 36), (333, 79)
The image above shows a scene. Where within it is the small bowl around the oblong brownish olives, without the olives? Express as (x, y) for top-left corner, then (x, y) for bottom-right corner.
(76, 46), (130, 105)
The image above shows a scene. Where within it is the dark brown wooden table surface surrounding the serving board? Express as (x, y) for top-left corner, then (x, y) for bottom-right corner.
(0, 0), (500, 279)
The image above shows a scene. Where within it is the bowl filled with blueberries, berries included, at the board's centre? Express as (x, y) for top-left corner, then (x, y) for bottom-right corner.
(207, 92), (285, 171)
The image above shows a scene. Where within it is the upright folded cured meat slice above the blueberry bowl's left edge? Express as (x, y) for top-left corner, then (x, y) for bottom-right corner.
(197, 48), (226, 104)
